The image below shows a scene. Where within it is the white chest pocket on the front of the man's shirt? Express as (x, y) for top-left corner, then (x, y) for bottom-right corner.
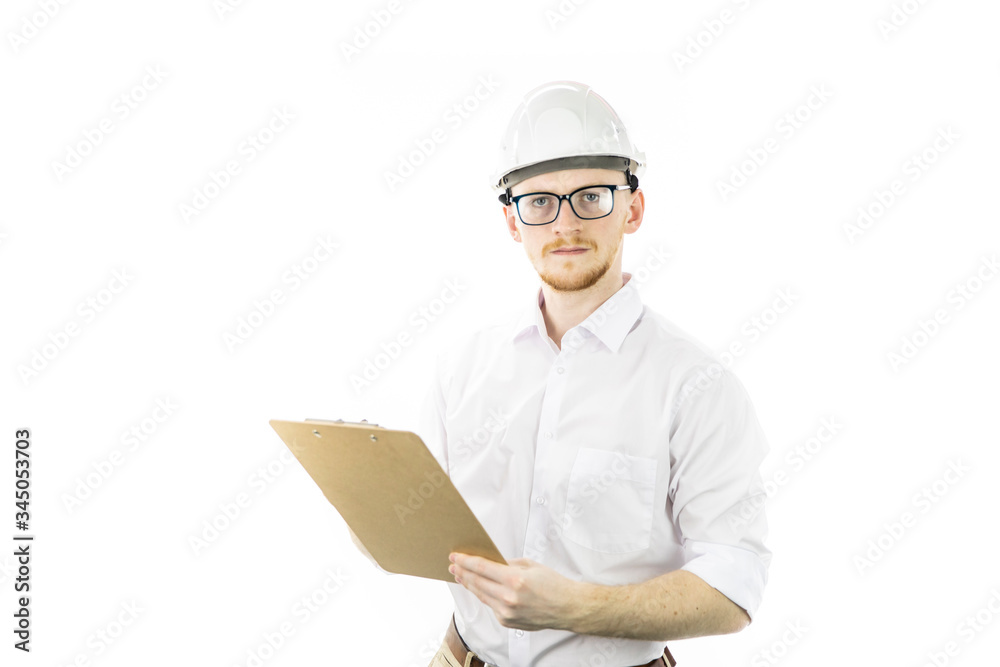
(563, 447), (657, 553)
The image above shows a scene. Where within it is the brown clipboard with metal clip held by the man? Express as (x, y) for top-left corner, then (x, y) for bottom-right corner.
(269, 419), (507, 583)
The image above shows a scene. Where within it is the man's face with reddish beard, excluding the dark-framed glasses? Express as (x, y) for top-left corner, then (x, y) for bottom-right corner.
(504, 169), (644, 292)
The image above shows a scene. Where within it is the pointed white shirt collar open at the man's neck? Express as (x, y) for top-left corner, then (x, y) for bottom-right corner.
(512, 271), (642, 352)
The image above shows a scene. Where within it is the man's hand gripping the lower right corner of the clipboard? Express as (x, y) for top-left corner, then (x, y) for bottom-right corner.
(448, 553), (583, 630)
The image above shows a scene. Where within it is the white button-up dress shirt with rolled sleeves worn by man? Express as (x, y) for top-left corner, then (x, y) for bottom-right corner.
(418, 272), (771, 667)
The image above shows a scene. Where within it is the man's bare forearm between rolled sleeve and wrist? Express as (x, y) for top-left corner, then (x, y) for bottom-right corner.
(567, 570), (750, 641)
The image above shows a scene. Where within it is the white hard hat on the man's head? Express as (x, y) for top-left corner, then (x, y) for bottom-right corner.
(492, 81), (646, 204)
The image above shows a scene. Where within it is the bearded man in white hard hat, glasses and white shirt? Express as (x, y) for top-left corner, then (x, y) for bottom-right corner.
(359, 81), (771, 667)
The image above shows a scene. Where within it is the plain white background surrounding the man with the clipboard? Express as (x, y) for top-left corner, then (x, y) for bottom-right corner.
(0, 0), (1000, 667)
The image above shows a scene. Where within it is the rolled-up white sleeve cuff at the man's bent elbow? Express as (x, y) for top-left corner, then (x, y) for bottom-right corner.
(681, 540), (771, 620)
